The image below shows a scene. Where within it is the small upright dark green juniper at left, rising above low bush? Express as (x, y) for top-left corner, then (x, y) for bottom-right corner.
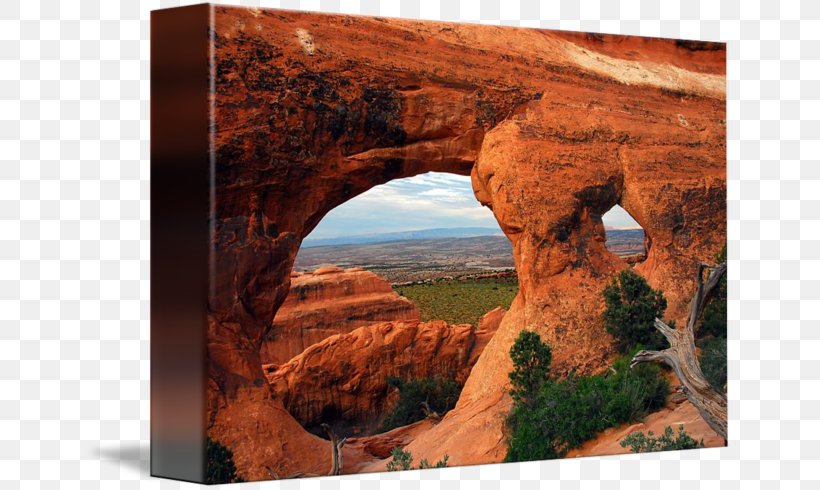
(509, 330), (552, 401)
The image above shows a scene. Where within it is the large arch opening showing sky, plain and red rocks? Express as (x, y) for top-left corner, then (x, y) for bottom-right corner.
(260, 172), (518, 437)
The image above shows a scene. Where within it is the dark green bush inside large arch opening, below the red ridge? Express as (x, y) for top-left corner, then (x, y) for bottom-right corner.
(381, 377), (461, 432)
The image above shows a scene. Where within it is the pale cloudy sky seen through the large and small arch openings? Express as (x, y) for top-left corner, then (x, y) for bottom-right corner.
(310, 172), (637, 239)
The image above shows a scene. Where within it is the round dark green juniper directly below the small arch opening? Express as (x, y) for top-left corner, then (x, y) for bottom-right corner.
(604, 269), (666, 353)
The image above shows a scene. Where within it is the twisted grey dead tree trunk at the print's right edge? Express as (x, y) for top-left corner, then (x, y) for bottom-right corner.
(630, 262), (728, 439)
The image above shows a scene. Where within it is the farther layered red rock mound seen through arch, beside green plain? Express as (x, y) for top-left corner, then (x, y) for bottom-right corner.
(260, 267), (419, 364)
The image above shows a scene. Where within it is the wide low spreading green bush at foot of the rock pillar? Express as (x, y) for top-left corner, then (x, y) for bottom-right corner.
(505, 332), (669, 461)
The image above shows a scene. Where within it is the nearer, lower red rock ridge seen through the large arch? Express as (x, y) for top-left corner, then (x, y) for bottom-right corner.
(263, 318), (503, 431)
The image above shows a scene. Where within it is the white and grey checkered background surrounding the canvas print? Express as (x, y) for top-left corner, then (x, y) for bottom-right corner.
(0, 0), (820, 490)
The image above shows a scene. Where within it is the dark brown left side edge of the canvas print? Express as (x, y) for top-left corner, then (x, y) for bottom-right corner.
(151, 4), (213, 482)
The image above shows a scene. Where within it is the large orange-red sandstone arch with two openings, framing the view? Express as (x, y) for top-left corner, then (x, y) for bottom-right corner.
(203, 3), (726, 480)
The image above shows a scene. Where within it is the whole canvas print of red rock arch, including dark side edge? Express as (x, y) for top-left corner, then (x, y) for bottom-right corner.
(151, 5), (728, 483)
